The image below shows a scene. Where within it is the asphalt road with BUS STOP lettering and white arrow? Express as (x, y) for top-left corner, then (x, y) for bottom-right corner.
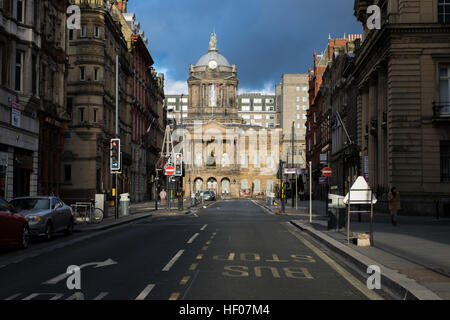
(0, 200), (379, 300)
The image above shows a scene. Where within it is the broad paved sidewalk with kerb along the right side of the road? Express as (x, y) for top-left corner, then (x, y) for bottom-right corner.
(257, 200), (450, 300)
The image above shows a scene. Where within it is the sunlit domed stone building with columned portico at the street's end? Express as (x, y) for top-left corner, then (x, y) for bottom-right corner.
(177, 34), (280, 198)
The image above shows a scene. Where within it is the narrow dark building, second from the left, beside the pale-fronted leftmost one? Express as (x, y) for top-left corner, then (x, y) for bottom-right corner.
(34, 0), (70, 195)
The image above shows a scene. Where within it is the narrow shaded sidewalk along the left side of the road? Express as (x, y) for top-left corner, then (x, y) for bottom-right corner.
(74, 200), (194, 232)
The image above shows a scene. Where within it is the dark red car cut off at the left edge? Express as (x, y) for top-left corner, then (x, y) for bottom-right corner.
(0, 198), (30, 249)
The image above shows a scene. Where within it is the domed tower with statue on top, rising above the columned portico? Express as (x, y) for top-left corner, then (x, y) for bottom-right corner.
(188, 33), (242, 123)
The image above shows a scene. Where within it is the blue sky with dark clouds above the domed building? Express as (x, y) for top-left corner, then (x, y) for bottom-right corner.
(127, 0), (362, 94)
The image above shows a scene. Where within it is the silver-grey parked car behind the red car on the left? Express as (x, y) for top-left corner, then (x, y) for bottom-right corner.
(10, 197), (74, 240)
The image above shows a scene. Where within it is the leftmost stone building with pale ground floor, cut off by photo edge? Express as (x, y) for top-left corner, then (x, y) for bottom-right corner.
(0, 0), (41, 200)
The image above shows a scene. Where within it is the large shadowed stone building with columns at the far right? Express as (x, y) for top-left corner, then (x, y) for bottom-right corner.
(353, 0), (450, 214)
